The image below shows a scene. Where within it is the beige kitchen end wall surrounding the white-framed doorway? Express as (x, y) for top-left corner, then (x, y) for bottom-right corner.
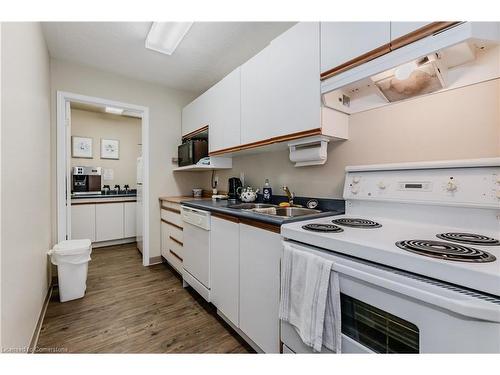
(50, 59), (204, 257)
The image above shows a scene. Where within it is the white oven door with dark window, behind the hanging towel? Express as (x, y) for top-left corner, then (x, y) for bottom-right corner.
(281, 242), (500, 353)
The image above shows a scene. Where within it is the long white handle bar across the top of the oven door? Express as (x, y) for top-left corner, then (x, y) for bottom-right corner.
(333, 262), (500, 322)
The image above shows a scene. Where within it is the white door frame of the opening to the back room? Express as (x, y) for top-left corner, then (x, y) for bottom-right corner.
(56, 91), (150, 266)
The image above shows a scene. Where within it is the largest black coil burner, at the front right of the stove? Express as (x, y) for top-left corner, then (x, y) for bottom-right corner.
(396, 240), (496, 263)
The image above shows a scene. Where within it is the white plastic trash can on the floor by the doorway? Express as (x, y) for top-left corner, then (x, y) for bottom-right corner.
(49, 240), (92, 302)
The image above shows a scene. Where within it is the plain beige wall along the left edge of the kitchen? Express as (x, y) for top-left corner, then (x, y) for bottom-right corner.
(1, 23), (52, 349)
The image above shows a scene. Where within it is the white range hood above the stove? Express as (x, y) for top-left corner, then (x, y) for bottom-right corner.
(321, 22), (500, 114)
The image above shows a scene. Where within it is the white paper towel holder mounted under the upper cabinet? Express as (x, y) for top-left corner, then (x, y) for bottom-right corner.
(288, 135), (330, 167)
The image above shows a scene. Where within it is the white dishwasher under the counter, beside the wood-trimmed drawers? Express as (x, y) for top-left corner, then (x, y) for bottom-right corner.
(181, 206), (210, 302)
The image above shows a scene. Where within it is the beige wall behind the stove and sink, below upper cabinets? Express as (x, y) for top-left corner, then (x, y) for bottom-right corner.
(210, 80), (500, 198)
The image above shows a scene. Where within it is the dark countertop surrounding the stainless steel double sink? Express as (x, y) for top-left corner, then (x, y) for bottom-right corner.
(181, 199), (345, 226)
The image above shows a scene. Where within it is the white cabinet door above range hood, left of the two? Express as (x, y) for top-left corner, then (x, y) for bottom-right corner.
(321, 22), (391, 72)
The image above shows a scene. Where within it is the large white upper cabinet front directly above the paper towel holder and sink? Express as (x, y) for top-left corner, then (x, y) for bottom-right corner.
(241, 22), (321, 144)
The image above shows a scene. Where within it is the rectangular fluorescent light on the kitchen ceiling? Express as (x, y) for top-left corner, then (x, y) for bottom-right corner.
(146, 22), (193, 55)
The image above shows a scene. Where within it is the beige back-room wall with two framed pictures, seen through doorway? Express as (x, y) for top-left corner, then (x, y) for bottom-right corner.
(71, 109), (141, 189)
